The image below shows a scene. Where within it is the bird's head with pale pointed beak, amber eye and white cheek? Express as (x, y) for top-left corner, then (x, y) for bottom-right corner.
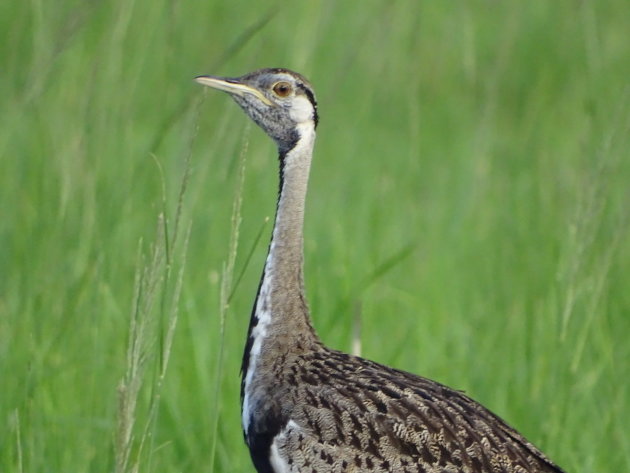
(195, 69), (318, 152)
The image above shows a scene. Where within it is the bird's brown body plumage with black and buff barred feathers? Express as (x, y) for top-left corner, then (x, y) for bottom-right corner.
(258, 347), (562, 473)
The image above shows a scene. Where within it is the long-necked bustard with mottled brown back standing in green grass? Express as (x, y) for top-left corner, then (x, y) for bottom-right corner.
(195, 68), (563, 473)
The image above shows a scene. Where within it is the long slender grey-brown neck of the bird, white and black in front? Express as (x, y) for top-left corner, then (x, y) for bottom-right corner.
(241, 122), (317, 438)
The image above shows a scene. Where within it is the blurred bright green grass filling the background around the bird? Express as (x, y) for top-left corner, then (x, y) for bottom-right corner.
(0, 0), (630, 472)
